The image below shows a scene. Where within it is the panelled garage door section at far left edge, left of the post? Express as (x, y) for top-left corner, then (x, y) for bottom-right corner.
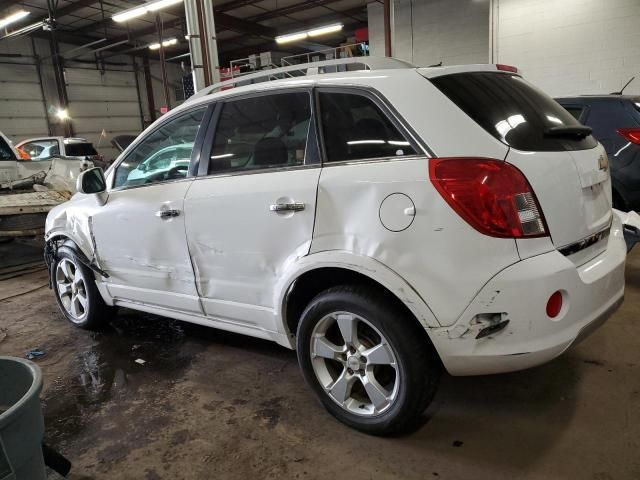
(0, 38), (49, 142)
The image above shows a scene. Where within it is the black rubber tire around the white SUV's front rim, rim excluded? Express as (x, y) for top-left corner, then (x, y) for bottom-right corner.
(51, 243), (115, 330)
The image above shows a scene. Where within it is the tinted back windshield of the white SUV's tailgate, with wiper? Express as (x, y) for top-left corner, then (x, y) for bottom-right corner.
(431, 72), (597, 152)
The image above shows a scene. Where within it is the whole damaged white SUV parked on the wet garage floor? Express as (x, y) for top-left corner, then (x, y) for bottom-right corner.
(46, 59), (626, 434)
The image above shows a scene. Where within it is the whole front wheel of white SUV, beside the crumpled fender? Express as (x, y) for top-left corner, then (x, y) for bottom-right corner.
(52, 245), (113, 330)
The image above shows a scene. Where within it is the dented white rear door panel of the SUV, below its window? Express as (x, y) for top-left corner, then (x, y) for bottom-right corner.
(185, 170), (320, 331)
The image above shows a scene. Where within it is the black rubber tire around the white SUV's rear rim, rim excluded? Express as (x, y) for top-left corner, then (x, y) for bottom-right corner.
(297, 286), (442, 435)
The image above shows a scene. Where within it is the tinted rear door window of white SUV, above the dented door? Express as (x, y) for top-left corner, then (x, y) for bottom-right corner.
(209, 92), (311, 174)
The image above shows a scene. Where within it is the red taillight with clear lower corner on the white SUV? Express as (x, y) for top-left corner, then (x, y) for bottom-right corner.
(429, 158), (548, 238)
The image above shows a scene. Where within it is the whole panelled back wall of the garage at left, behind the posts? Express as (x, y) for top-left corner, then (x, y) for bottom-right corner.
(0, 37), (188, 159)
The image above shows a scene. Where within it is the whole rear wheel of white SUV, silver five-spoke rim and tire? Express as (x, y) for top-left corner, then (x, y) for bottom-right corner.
(297, 286), (441, 435)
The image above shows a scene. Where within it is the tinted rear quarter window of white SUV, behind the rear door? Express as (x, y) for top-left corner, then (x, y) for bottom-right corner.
(320, 92), (416, 162)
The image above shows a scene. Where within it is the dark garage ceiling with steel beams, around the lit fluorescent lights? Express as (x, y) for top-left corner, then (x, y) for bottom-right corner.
(0, 0), (372, 66)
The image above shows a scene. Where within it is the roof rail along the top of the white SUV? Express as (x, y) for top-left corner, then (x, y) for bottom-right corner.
(187, 56), (415, 101)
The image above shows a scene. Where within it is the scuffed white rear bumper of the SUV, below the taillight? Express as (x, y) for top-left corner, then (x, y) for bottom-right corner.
(429, 215), (626, 375)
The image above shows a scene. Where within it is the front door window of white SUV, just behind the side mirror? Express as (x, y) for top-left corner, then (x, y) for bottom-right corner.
(113, 107), (206, 188)
